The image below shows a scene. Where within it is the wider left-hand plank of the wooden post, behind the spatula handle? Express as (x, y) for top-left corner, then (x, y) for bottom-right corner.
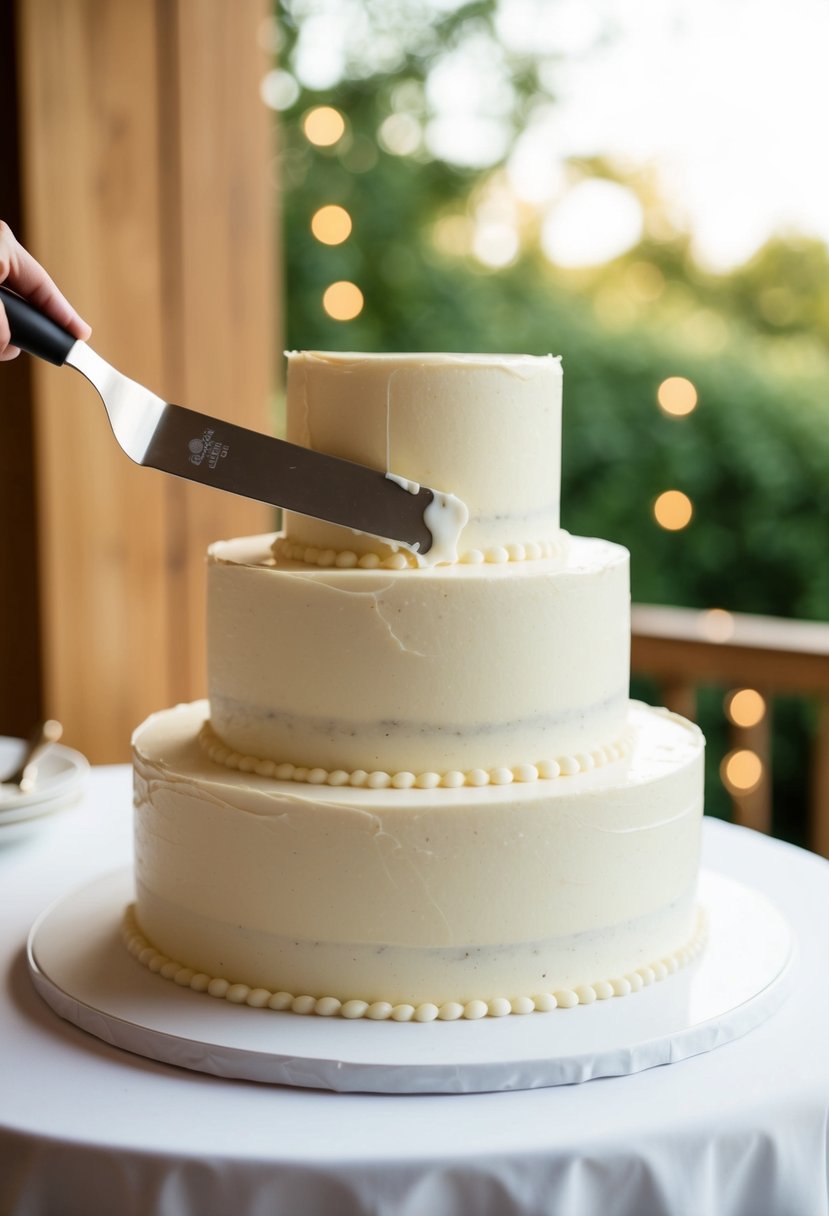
(18, 0), (168, 760)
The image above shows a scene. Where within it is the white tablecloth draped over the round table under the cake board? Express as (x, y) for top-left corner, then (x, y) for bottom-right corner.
(0, 767), (829, 1216)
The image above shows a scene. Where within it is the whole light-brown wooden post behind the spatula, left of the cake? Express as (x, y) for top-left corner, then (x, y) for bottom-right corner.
(17, 0), (274, 761)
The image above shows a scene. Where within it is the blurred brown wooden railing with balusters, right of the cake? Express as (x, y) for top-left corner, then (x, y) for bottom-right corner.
(631, 604), (829, 857)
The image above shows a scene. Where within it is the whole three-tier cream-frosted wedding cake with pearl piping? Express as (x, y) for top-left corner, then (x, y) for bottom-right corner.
(125, 354), (703, 1021)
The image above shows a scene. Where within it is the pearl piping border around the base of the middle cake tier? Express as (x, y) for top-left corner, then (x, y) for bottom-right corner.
(198, 721), (631, 789)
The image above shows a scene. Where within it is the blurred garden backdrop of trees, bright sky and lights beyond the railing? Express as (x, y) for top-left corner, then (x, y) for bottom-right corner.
(267, 0), (829, 841)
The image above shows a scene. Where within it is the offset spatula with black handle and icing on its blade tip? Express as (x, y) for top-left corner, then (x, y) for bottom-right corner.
(0, 287), (467, 565)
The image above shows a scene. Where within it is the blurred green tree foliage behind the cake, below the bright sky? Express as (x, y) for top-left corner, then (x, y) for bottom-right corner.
(278, 0), (829, 840)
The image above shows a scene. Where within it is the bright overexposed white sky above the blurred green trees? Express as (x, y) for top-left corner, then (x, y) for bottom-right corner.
(285, 0), (829, 268)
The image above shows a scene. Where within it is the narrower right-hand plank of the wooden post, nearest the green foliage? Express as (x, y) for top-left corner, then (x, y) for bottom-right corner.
(165, 0), (274, 699)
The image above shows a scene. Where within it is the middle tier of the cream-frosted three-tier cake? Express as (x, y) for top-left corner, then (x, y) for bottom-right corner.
(208, 536), (630, 786)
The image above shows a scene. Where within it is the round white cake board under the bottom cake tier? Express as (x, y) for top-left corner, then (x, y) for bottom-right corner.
(28, 871), (794, 1093)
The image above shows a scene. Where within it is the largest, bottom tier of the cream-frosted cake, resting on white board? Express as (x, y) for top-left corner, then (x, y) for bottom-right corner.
(125, 702), (704, 1020)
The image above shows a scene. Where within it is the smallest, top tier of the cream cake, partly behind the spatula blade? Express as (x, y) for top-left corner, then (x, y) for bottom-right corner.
(284, 351), (562, 557)
